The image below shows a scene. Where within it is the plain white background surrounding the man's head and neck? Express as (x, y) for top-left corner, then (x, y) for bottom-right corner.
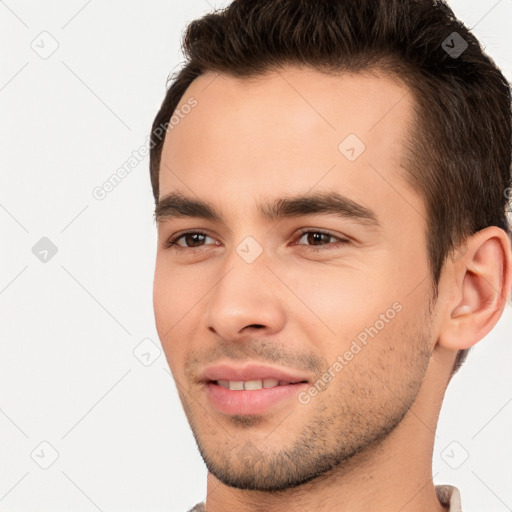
(0, 0), (512, 512)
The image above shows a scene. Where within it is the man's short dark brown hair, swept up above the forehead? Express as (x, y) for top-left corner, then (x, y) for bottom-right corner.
(150, 0), (512, 375)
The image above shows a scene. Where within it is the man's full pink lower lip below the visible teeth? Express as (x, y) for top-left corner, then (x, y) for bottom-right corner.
(206, 382), (308, 415)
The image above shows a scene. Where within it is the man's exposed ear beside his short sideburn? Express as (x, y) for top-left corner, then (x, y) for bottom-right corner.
(438, 226), (512, 350)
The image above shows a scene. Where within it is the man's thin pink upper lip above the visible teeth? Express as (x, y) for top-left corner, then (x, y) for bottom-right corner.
(202, 363), (309, 383)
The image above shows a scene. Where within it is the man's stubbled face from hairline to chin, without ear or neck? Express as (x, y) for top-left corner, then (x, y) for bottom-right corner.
(153, 67), (435, 491)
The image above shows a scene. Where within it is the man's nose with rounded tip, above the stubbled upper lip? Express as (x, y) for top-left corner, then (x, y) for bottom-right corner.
(204, 247), (289, 341)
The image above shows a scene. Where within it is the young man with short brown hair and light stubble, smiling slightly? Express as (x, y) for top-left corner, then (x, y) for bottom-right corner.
(150, 0), (512, 512)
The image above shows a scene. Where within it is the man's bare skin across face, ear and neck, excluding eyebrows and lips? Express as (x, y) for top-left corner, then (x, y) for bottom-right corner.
(153, 67), (512, 512)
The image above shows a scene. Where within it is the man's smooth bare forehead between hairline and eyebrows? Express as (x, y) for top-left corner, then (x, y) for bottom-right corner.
(160, 67), (422, 228)
